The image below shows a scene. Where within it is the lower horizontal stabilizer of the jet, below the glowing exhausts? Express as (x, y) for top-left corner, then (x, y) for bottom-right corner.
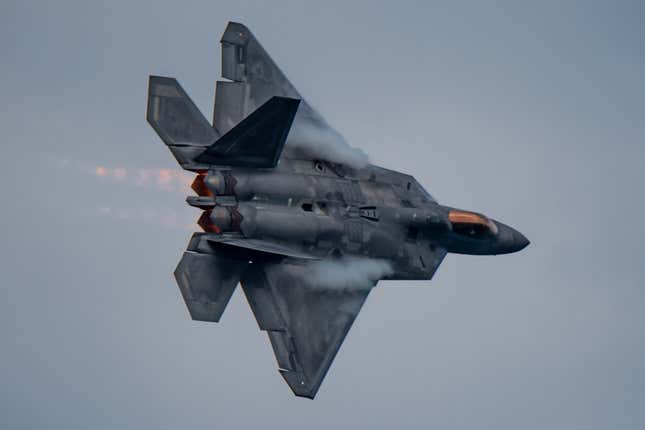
(175, 234), (248, 322)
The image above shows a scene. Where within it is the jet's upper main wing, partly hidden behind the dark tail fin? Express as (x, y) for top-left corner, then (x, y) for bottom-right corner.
(213, 22), (368, 167)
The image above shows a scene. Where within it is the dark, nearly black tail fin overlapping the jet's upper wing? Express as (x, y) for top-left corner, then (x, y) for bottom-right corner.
(196, 97), (300, 168)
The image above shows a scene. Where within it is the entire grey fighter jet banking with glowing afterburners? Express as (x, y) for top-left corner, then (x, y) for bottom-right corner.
(147, 22), (529, 399)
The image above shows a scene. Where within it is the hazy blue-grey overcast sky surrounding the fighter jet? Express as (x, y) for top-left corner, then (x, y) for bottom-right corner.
(0, 0), (645, 430)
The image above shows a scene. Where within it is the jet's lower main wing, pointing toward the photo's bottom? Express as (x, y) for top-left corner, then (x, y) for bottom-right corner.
(242, 259), (370, 399)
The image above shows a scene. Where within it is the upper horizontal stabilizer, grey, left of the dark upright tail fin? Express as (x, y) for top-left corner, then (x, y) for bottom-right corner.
(147, 76), (219, 171)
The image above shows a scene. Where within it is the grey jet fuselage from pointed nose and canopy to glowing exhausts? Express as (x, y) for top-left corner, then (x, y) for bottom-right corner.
(188, 158), (528, 279)
